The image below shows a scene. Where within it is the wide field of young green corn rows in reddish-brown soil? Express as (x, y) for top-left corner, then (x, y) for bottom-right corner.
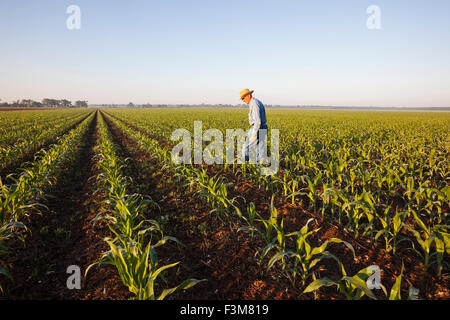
(0, 108), (450, 300)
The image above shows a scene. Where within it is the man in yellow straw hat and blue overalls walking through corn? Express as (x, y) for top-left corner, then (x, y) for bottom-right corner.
(240, 89), (267, 164)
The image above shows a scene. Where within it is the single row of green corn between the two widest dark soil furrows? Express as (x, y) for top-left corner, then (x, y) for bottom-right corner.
(86, 112), (202, 300)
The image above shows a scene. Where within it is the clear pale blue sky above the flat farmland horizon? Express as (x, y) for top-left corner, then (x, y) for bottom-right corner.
(0, 0), (450, 107)
